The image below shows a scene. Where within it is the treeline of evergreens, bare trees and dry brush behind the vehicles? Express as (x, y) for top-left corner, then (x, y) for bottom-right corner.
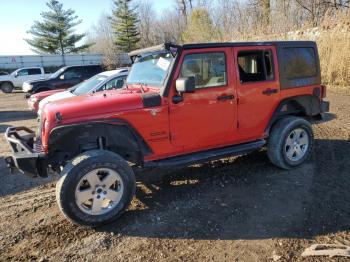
(27, 0), (350, 85)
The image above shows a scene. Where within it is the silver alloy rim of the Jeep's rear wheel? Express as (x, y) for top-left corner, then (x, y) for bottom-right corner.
(284, 128), (309, 162)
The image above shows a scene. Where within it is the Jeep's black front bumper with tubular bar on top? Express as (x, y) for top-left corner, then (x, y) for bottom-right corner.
(5, 127), (47, 177)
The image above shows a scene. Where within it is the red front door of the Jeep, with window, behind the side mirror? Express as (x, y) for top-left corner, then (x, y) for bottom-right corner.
(169, 48), (237, 151)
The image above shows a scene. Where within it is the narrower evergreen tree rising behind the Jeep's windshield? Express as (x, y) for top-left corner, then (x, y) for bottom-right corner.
(112, 0), (140, 52)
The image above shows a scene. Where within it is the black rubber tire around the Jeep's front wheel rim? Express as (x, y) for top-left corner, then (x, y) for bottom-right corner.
(56, 150), (136, 227)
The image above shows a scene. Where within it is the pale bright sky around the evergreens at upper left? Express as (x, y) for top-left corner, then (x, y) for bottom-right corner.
(0, 0), (174, 56)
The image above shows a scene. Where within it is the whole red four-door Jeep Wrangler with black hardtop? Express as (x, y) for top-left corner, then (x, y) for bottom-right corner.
(5, 41), (329, 226)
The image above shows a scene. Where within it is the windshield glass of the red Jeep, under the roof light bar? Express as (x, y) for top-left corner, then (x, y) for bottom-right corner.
(126, 52), (174, 87)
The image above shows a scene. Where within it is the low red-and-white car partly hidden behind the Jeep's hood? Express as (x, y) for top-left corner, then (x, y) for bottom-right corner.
(27, 69), (128, 115)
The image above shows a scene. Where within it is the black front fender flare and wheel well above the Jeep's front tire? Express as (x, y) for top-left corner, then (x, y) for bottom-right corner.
(48, 119), (153, 165)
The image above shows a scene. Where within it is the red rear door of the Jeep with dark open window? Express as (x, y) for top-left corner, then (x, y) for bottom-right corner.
(234, 46), (280, 139)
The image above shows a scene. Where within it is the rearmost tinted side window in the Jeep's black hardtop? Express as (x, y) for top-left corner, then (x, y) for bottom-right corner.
(283, 47), (317, 79)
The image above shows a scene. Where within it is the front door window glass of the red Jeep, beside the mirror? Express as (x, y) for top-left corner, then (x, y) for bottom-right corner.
(180, 52), (227, 89)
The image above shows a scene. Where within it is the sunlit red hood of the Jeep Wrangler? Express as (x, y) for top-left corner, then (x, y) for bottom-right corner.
(43, 87), (159, 124)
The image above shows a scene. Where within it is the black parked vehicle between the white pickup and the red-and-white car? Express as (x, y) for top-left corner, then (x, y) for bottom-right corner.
(22, 65), (102, 95)
